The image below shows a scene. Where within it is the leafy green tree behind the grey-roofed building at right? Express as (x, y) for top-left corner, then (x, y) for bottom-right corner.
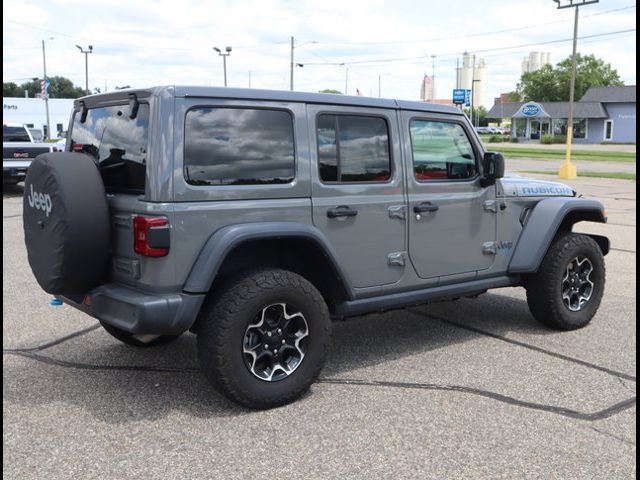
(517, 53), (624, 102)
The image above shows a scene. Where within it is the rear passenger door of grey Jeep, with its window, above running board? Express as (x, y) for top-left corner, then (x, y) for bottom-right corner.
(307, 105), (406, 288)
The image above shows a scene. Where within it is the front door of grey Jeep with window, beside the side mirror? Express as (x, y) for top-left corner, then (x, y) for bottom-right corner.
(403, 112), (497, 283)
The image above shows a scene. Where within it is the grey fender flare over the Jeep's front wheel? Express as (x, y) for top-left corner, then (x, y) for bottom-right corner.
(508, 197), (608, 274)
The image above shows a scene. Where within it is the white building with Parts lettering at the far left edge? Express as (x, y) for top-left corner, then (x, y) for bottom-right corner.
(2, 97), (73, 138)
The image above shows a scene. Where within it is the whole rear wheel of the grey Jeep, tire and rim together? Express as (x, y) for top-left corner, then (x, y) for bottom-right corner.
(197, 269), (331, 409)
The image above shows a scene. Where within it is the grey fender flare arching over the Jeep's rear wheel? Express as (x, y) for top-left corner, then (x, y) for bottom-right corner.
(183, 222), (354, 299)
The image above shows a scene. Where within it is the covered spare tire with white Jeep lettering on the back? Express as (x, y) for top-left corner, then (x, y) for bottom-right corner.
(22, 152), (110, 295)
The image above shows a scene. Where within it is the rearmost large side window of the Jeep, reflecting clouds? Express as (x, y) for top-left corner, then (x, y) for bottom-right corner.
(184, 107), (295, 185)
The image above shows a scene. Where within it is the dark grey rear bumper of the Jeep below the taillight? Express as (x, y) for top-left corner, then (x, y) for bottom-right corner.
(59, 284), (205, 335)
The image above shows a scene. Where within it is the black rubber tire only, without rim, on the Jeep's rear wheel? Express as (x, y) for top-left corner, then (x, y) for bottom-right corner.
(197, 269), (331, 409)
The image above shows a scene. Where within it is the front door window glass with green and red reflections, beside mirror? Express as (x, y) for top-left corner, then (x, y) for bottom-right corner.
(410, 120), (478, 181)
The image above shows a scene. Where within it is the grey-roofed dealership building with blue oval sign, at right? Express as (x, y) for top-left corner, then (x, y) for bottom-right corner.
(487, 85), (636, 143)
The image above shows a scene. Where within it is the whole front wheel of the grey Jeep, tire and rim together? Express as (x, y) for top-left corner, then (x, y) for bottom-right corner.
(526, 233), (605, 330)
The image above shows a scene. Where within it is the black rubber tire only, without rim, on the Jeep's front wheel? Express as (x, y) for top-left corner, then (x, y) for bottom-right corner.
(526, 233), (605, 330)
